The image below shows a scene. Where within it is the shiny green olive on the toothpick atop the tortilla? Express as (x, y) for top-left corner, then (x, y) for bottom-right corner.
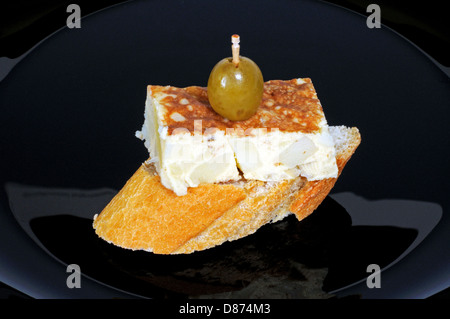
(208, 56), (264, 121)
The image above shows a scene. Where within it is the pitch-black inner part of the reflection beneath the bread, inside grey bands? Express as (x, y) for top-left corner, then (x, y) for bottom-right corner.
(30, 197), (417, 298)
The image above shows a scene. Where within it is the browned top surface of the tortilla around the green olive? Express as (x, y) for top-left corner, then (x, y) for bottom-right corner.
(148, 78), (324, 135)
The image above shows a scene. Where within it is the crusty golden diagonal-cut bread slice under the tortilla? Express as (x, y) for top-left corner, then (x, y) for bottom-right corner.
(93, 126), (361, 254)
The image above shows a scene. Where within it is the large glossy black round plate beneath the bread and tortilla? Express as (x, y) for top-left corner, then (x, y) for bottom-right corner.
(0, 1), (450, 298)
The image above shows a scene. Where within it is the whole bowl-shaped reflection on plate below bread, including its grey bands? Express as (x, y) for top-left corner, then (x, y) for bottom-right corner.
(7, 184), (440, 298)
